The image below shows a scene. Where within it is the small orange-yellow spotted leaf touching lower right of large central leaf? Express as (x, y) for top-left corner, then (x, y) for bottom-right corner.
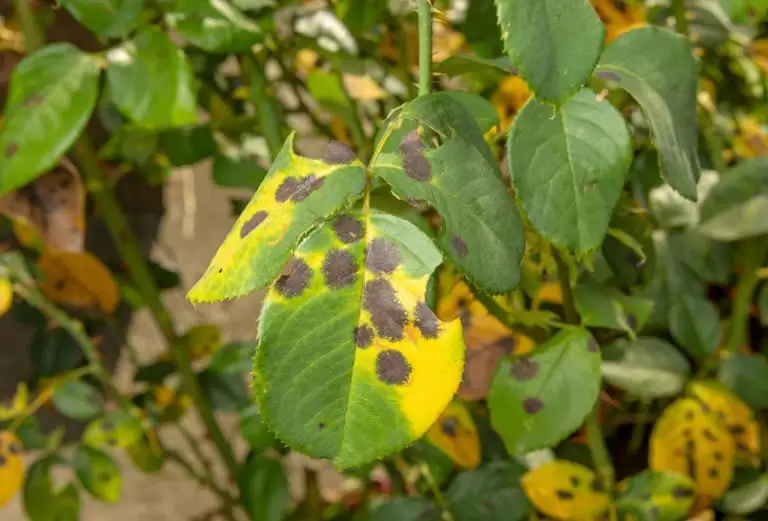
(426, 401), (480, 469)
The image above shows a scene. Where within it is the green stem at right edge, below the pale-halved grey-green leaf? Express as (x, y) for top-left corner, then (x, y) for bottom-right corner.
(728, 235), (768, 353)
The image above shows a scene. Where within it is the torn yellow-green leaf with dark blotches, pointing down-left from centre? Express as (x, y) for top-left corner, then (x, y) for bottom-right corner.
(188, 134), (365, 302)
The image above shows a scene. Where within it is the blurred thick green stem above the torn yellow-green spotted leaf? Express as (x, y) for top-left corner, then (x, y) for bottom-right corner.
(240, 53), (286, 161)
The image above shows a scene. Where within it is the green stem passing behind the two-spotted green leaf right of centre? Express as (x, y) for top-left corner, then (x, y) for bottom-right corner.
(553, 250), (616, 494)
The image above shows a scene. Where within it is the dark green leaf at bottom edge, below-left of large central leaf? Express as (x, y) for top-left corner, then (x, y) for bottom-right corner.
(238, 452), (291, 521)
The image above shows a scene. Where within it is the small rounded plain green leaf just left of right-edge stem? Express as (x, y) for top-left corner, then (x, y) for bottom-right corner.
(669, 294), (720, 358)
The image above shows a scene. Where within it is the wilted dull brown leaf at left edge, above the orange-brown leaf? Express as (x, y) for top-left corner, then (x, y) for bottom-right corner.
(0, 159), (85, 252)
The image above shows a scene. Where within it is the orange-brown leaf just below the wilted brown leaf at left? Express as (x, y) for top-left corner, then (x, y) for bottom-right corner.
(39, 250), (120, 314)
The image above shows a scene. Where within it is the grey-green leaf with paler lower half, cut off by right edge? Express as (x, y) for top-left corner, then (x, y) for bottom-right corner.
(699, 156), (768, 241)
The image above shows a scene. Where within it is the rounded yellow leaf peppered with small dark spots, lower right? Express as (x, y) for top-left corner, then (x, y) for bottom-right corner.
(649, 398), (735, 504)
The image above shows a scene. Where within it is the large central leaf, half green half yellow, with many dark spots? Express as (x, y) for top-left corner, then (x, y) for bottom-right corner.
(254, 212), (464, 468)
